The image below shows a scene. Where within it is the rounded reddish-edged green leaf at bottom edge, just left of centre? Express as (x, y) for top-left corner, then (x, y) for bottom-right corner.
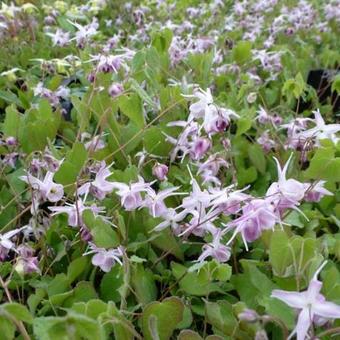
(142, 296), (184, 340)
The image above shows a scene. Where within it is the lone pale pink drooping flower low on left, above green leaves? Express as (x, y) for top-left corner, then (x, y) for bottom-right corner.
(83, 243), (124, 273)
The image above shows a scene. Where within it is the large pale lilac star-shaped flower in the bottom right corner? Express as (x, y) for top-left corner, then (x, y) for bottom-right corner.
(271, 261), (340, 340)
